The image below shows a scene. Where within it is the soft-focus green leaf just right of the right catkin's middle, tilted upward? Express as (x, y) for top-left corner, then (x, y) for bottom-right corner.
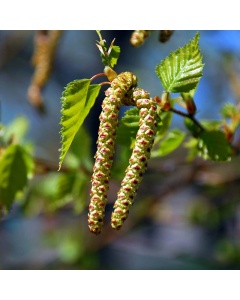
(151, 129), (186, 157)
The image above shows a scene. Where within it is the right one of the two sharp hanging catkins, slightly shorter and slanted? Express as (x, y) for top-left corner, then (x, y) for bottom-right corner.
(111, 88), (157, 230)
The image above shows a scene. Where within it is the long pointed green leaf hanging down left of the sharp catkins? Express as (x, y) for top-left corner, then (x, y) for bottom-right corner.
(59, 79), (101, 170)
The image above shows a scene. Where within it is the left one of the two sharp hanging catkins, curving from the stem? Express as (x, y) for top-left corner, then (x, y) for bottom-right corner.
(88, 72), (137, 234)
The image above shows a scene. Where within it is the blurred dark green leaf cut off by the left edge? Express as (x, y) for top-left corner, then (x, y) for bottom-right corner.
(0, 144), (34, 209)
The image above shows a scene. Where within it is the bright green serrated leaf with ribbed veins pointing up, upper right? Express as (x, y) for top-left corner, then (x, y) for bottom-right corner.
(156, 33), (204, 93)
